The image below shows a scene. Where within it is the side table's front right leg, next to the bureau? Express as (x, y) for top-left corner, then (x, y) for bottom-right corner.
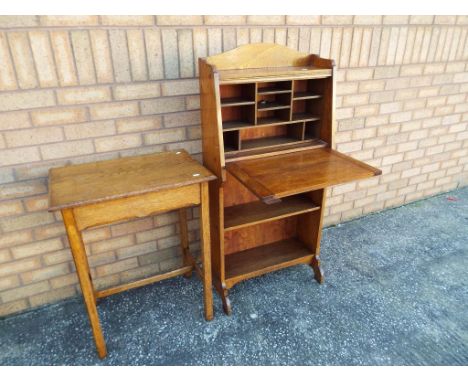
(200, 182), (213, 321)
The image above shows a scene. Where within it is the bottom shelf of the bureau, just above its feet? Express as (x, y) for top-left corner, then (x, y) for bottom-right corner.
(225, 238), (314, 289)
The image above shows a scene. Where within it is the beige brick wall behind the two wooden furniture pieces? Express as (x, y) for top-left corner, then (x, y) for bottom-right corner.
(0, 16), (468, 316)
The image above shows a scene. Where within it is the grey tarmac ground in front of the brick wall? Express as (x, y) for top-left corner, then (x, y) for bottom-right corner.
(0, 188), (468, 365)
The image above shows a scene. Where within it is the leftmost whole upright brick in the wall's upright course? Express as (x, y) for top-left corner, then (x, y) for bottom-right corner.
(8, 32), (38, 89)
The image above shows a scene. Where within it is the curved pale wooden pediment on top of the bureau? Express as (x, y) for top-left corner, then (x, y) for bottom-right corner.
(206, 43), (310, 70)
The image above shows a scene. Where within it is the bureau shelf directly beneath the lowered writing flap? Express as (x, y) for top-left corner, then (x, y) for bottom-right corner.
(224, 195), (320, 231)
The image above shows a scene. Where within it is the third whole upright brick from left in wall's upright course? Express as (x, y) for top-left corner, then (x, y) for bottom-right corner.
(50, 31), (78, 86)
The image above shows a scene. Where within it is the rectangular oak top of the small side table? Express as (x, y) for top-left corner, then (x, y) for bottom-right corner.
(49, 150), (216, 211)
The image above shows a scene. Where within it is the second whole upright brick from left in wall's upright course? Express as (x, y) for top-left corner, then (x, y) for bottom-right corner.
(29, 31), (58, 87)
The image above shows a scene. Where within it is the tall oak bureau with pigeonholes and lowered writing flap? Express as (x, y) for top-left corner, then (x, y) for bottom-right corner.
(200, 44), (380, 314)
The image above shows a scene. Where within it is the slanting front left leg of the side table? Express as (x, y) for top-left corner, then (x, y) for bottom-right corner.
(62, 209), (107, 358)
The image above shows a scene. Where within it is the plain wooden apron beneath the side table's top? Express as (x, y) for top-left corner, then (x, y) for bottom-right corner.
(73, 184), (201, 231)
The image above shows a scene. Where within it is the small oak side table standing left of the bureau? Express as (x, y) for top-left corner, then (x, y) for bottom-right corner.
(49, 150), (216, 358)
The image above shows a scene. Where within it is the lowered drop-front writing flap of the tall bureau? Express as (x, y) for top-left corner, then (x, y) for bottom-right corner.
(226, 148), (381, 203)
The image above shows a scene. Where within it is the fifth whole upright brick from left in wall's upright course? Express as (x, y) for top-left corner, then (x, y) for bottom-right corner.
(89, 30), (114, 83)
